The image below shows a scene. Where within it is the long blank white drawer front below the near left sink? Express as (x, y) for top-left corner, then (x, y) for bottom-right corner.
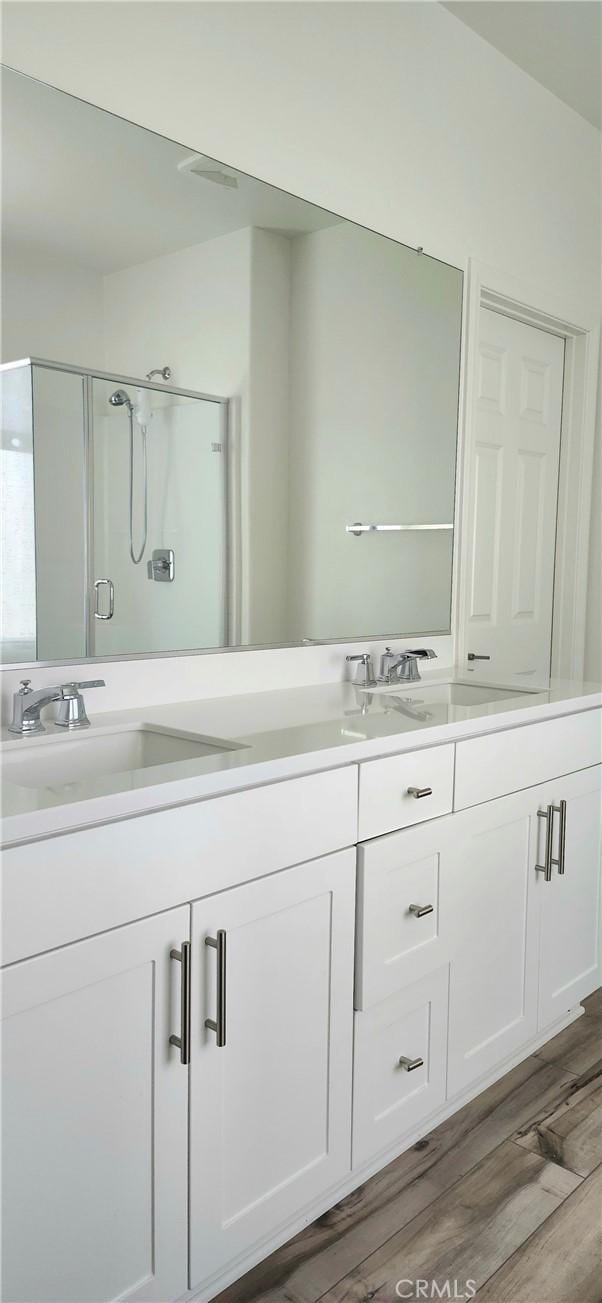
(3, 766), (357, 964)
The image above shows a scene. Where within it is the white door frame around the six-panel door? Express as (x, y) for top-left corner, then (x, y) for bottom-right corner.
(453, 258), (599, 679)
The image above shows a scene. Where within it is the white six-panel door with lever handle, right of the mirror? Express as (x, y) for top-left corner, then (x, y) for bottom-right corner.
(460, 308), (564, 687)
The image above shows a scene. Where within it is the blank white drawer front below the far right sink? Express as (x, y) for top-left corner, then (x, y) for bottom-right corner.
(453, 710), (602, 809)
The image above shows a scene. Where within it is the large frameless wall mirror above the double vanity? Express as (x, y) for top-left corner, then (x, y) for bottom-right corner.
(1, 70), (463, 663)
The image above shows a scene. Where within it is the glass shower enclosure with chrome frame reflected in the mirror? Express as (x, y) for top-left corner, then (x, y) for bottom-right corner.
(0, 360), (228, 663)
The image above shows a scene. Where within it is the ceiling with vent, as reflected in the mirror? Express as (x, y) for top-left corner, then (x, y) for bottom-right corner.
(3, 70), (340, 274)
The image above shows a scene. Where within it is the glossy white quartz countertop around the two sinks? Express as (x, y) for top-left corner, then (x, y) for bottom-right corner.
(1, 671), (602, 846)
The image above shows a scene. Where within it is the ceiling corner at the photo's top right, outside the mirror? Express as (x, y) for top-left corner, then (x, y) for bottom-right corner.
(444, 0), (602, 128)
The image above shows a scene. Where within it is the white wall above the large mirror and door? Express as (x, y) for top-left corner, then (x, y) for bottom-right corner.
(4, 0), (601, 693)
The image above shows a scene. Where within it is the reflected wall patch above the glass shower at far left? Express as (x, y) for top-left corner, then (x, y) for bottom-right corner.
(1, 239), (103, 366)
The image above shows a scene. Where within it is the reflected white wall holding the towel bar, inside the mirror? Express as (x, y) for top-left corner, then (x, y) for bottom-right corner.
(289, 223), (463, 640)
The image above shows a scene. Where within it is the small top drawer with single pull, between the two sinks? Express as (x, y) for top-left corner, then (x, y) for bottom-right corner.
(360, 745), (453, 842)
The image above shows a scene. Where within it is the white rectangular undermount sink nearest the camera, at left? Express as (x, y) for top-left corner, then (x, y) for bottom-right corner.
(3, 724), (240, 791)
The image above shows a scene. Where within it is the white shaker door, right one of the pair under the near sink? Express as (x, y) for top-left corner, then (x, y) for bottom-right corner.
(190, 851), (356, 1289)
